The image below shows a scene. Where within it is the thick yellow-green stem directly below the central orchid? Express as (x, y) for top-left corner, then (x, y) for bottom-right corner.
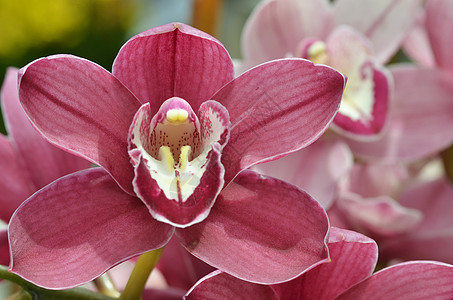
(119, 247), (164, 300)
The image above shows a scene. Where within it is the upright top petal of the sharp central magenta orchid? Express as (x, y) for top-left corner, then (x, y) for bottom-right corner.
(113, 23), (234, 111)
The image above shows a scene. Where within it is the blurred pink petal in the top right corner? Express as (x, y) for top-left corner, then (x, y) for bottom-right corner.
(426, 0), (453, 71)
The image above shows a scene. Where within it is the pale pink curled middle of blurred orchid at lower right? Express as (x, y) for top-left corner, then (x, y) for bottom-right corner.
(331, 163), (422, 239)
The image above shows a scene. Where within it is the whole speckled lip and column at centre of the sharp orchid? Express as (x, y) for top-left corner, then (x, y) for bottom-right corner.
(129, 97), (230, 227)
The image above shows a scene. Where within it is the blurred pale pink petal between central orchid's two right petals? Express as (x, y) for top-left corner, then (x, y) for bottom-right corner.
(253, 139), (353, 209)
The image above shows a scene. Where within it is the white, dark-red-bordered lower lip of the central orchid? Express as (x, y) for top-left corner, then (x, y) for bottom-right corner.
(132, 144), (224, 227)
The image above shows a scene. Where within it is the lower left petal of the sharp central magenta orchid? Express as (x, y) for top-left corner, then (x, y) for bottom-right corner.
(9, 168), (173, 289)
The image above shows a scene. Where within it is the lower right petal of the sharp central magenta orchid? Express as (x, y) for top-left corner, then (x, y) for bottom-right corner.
(176, 171), (328, 284)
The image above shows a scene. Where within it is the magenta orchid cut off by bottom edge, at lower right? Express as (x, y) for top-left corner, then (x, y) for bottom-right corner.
(184, 228), (453, 300)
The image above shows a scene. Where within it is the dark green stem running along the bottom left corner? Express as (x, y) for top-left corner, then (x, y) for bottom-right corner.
(0, 265), (114, 300)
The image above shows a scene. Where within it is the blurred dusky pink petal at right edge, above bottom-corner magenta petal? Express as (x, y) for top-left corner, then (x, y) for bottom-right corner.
(382, 179), (453, 263)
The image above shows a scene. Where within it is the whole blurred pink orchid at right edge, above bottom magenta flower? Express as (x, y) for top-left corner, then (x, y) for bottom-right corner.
(328, 157), (453, 263)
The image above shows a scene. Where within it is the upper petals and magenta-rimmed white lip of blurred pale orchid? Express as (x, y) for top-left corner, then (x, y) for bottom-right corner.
(242, 0), (419, 142)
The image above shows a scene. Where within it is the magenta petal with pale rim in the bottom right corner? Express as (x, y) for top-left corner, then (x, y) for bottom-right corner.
(336, 261), (453, 300)
